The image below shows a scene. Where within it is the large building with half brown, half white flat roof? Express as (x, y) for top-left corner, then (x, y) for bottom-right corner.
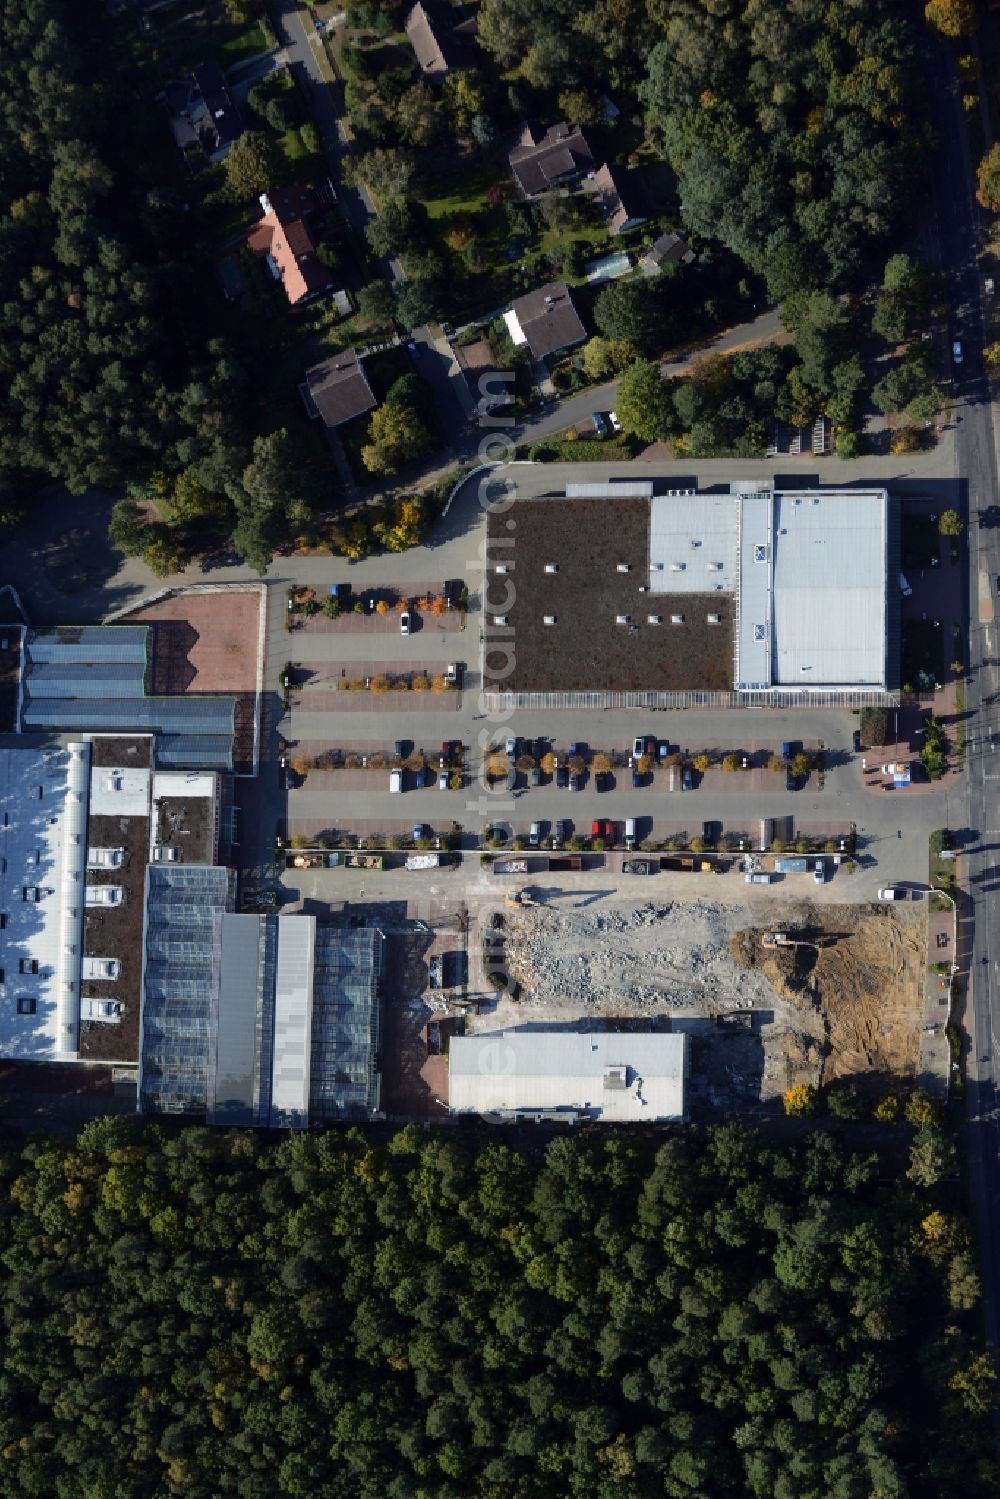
(483, 480), (900, 708)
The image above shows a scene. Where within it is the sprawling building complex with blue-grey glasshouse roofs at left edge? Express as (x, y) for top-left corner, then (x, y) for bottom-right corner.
(0, 602), (384, 1129)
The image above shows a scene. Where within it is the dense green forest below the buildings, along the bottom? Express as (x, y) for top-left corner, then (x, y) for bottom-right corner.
(0, 1120), (1000, 1499)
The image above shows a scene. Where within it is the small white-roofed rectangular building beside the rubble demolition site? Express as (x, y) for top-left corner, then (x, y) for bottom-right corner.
(448, 1030), (688, 1124)
